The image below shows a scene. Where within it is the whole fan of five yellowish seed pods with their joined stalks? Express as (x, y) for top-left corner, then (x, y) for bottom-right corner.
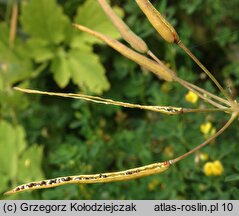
(6, 0), (239, 194)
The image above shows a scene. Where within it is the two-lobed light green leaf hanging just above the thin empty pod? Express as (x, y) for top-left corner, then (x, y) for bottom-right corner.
(51, 44), (110, 94)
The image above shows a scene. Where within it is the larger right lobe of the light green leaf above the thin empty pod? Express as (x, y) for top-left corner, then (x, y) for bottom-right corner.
(69, 47), (110, 94)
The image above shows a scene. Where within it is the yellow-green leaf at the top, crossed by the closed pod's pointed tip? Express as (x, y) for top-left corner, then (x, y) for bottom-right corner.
(71, 0), (123, 47)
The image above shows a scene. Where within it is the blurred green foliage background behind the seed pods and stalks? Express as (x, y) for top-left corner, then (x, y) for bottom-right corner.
(0, 0), (239, 199)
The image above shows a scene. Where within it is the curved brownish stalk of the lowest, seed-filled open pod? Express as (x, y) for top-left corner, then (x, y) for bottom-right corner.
(171, 112), (238, 164)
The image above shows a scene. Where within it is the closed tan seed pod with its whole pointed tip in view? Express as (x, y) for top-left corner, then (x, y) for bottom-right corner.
(73, 24), (175, 81)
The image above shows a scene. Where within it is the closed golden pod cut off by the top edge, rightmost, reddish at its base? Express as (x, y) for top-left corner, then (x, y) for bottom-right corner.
(135, 0), (180, 43)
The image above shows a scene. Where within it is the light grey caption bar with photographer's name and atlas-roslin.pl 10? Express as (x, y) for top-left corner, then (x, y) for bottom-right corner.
(0, 200), (239, 216)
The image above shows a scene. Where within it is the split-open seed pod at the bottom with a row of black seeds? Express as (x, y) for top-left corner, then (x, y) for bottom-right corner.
(5, 161), (172, 194)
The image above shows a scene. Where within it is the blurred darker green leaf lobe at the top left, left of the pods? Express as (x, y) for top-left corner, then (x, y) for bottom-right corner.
(21, 0), (69, 44)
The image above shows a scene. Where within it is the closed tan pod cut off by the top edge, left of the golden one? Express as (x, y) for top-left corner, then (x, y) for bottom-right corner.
(98, 0), (149, 53)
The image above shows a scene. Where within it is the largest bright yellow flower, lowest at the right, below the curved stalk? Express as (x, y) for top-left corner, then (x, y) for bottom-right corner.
(203, 160), (224, 176)
